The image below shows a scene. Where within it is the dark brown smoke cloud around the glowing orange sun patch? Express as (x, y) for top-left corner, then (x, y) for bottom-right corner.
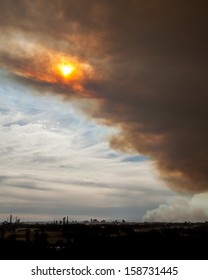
(0, 0), (208, 192)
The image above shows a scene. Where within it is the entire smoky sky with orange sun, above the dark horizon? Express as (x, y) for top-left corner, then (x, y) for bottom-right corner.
(0, 0), (208, 222)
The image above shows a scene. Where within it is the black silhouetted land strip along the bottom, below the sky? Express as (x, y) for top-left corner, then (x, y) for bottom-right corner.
(0, 222), (208, 260)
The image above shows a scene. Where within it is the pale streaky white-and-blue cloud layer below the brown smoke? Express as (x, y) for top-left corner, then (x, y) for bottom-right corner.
(0, 76), (172, 221)
